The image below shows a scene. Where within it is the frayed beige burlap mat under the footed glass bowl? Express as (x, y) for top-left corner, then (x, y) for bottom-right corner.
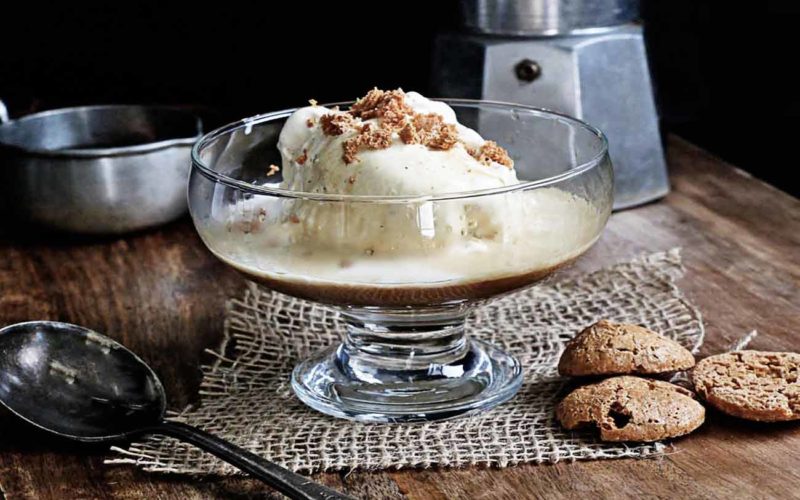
(109, 250), (703, 474)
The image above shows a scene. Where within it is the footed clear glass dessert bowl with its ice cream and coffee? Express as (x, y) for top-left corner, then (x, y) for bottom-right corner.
(189, 90), (613, 422)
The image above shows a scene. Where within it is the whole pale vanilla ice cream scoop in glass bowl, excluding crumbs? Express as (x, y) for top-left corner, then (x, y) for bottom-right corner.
(258, 92), (532, 253)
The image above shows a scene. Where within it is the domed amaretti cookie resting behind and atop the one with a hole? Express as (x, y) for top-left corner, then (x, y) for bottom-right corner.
(558, 320), (694, 376)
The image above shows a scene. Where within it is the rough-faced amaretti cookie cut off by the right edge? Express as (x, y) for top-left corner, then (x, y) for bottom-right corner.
(692, 351), (800, 422)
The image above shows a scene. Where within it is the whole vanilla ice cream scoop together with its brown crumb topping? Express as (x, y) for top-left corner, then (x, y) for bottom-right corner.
(260, 90), (519, 255)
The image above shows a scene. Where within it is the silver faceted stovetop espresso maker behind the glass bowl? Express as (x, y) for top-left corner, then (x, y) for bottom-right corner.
(433, 0), (669, 209)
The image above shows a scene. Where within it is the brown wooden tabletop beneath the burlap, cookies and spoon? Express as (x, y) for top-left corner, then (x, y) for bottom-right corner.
(0, 137), (800, 499)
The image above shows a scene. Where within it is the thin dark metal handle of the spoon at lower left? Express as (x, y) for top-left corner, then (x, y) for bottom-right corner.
(155, 420), (353, 500)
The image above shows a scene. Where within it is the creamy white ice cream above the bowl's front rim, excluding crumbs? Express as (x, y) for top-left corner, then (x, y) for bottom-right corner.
(278, 92), (518, 196)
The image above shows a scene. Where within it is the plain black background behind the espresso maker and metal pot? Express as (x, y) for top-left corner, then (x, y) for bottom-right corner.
(0, 0), (800, 194)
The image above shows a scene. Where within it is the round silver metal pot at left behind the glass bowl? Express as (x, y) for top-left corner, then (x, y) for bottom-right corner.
(0, 105), (202, 234)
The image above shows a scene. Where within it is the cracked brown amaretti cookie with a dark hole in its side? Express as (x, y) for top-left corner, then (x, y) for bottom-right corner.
(556, 376), (705, 441)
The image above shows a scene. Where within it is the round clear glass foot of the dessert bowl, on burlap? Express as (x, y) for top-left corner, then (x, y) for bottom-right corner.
(292, 339), (522, 423)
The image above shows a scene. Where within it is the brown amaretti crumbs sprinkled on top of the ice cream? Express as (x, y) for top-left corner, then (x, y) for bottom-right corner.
(314, 88), (514, 168)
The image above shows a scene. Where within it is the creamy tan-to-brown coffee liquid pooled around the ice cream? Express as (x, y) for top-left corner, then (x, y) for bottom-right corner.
(200, 189), (607, 307)
